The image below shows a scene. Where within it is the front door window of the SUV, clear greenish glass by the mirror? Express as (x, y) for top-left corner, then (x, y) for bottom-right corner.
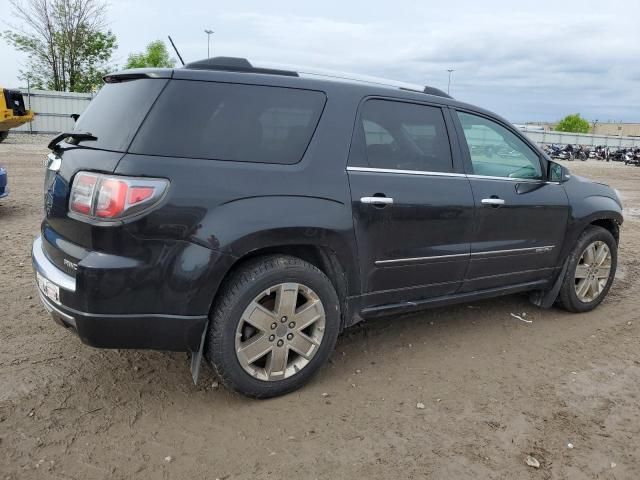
(457, 112), (542, 179)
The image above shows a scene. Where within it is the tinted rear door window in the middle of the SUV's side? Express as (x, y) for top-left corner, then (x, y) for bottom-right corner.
(361, 100), (452, 172)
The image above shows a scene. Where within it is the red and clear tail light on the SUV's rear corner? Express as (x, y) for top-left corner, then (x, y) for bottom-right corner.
(69, 172), (169, 221)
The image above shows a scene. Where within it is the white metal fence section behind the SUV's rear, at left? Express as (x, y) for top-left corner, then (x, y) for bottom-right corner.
(15, 89), (93, 133)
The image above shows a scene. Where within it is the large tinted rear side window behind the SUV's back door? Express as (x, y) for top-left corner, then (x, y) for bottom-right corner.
(129, 80), (325, 164)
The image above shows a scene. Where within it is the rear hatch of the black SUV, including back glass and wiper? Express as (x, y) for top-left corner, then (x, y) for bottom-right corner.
(42, 75), (172, 274)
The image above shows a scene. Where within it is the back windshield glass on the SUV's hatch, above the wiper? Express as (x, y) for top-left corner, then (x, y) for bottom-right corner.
(73, 78), (167, 152)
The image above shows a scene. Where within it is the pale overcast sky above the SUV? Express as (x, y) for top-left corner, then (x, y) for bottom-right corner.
(0, 0), (640, 123)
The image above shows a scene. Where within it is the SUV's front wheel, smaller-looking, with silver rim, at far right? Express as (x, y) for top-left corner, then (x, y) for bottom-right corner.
(558, 226), (618, 312)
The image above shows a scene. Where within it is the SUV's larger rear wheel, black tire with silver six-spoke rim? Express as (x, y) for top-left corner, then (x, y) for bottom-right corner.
(205, 255), (341, 398)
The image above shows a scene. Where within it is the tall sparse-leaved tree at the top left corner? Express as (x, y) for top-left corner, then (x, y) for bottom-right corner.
(2, 0), (117, 92)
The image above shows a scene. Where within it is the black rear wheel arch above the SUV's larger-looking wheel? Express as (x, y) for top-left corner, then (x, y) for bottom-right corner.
(196, 193), (361, 324)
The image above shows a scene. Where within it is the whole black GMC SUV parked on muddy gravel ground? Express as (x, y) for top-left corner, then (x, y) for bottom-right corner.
(33, 58), (622, 398)
